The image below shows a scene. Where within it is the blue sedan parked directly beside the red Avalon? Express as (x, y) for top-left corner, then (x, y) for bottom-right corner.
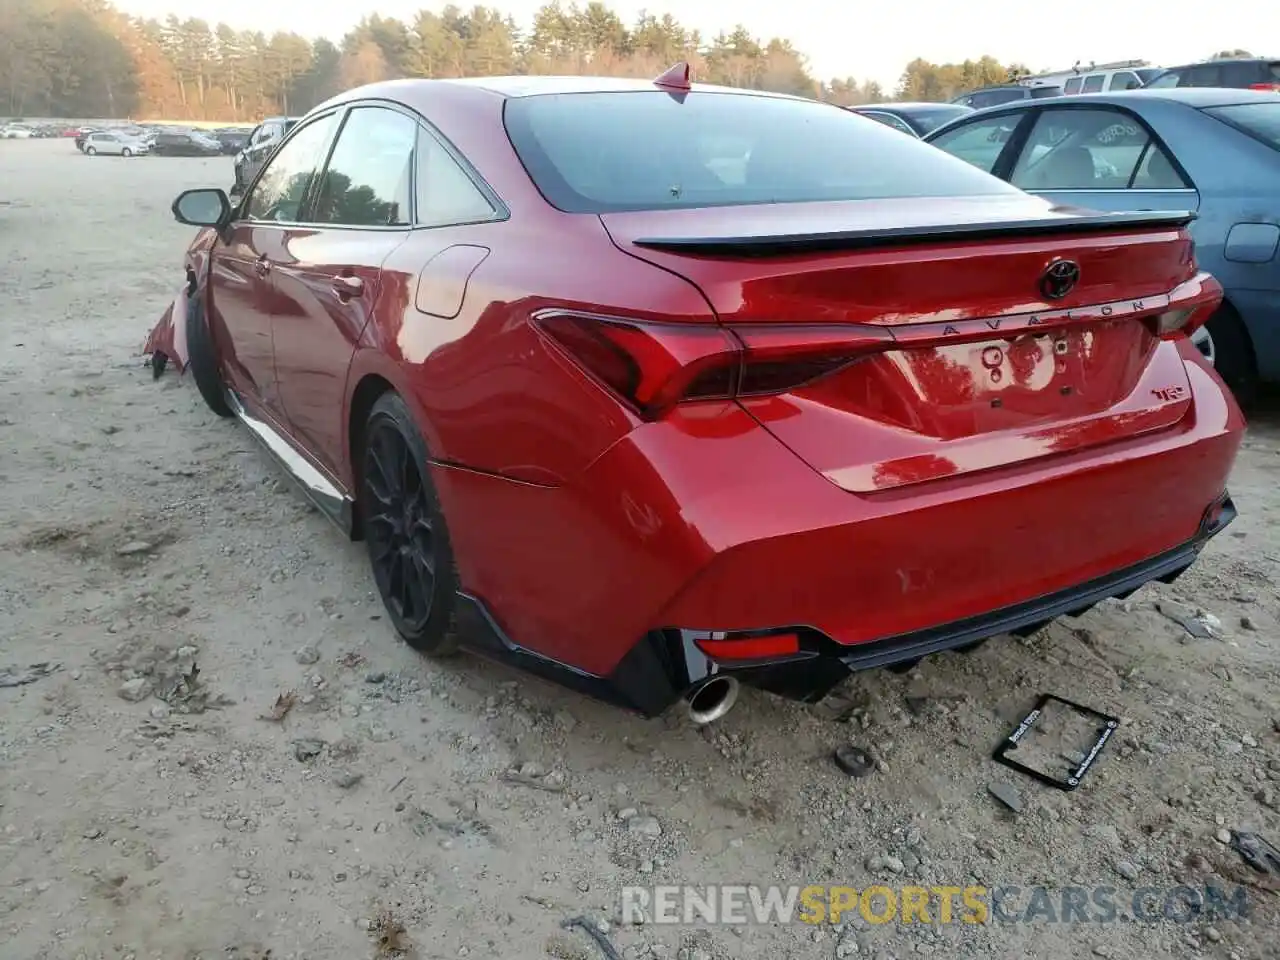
(927, 88), (1280, 403)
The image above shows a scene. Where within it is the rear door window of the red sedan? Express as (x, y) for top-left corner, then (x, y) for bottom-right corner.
(307, 106), (417, 227)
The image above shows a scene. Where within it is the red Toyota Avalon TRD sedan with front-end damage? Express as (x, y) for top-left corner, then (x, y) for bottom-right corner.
(146, 65), (1244, 722)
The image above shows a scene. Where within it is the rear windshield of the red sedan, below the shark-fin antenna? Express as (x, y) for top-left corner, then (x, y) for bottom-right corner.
(504, 91), (1018, 214)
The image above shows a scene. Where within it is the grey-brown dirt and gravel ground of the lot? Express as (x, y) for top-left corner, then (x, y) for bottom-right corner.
(0, 141), (1280, 960)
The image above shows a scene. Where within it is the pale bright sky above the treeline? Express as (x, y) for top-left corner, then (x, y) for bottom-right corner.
(116, 0), (1280, 88)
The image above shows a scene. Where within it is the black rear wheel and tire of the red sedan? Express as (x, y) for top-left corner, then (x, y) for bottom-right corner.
(357, 393), (458, 657)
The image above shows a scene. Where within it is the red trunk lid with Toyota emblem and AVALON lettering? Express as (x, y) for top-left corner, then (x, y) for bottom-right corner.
(602, 196), (1216, 493)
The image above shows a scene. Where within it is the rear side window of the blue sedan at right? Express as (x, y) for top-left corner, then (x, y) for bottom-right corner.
(1010, 110), (1181, 191)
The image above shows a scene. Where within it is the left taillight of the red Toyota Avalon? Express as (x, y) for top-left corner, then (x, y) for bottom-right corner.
(534, 311), (893, 420)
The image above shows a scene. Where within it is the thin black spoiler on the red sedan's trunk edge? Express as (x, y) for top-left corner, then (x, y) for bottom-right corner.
(632, 210), (1197, 257)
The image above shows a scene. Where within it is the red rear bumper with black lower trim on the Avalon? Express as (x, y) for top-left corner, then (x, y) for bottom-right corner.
(439, 343), (1244, 714)
